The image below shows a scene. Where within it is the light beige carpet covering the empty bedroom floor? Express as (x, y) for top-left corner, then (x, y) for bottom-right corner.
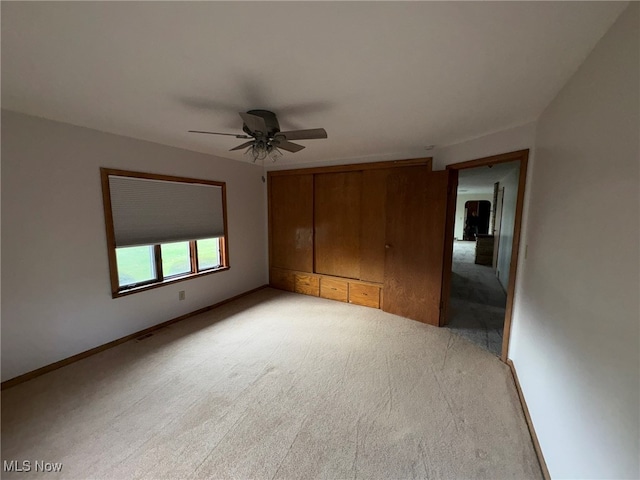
(2, 289), (541, 480)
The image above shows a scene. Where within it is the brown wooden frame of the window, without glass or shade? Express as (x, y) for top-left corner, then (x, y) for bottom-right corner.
(100, 168), (230, 298)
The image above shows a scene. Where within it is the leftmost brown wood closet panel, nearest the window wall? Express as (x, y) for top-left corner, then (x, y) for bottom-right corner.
(269, 175), (313, 272)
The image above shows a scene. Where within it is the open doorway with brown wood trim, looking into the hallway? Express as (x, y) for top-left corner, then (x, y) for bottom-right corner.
(446, 150), (529, 361)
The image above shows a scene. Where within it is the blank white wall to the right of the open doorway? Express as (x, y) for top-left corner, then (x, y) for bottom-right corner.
(510, 2), (640, 479)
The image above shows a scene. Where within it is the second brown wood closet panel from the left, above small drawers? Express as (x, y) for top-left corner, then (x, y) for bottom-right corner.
(314, 172), (362, 278)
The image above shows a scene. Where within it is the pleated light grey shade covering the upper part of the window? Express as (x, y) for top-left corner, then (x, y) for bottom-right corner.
(109, 175), (225, 247)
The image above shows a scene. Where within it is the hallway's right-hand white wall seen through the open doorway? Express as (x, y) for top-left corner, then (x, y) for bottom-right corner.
(496, 166), (520, 291)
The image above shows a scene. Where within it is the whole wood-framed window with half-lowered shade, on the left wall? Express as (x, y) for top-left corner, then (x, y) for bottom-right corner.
(101, 168), (229, 298)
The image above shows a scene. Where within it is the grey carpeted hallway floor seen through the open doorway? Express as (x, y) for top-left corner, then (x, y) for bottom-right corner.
(447, 241), (507, 356)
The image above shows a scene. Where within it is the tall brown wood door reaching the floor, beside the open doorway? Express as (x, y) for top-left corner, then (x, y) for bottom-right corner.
(383, 171), (455, 326)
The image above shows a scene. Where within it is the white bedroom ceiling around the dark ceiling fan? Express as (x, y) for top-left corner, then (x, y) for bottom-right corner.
(2, 2), (626, 166)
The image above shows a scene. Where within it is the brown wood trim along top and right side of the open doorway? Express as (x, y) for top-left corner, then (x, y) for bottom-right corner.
(446, 148), (529, 363)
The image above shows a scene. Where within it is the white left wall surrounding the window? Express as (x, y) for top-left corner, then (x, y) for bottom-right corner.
(2, 110), (267, 380)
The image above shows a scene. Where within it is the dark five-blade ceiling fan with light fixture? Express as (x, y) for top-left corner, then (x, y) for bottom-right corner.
(189, 110), (327, 162)
